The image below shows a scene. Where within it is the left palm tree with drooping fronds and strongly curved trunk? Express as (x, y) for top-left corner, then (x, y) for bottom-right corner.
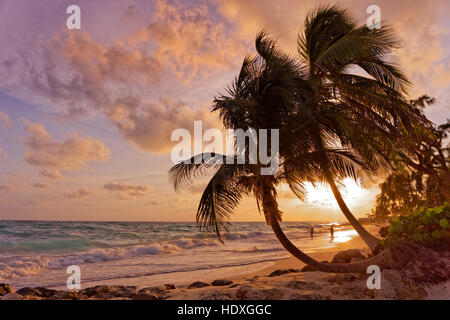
(170, 34), (384, 272)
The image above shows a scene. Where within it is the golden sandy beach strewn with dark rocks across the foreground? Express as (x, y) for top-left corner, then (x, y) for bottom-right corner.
(3, 226), (450, 300)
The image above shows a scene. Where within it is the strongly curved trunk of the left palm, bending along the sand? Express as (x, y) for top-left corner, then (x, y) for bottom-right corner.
(262, 182), (393, 273)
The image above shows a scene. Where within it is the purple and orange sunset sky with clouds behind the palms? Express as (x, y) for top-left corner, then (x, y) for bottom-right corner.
(0, 0), (450, 221)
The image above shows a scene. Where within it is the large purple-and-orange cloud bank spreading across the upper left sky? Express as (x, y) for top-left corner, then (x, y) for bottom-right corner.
(0, 0), (237, 153)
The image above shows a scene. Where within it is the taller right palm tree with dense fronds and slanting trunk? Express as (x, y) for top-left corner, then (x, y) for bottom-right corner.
(286, 6), (434, 252)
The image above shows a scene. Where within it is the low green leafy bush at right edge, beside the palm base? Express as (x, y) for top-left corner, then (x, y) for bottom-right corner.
(384, 202), (450, 248)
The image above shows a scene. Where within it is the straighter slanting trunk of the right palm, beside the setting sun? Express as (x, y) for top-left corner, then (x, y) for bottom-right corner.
(324, 169), (381, 254)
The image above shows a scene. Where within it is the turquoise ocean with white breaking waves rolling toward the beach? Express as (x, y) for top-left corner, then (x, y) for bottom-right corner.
(0, 221), (355, 289)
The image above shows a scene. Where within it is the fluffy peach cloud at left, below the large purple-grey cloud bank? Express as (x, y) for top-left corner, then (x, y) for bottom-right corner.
(25, 121), (110, 178)
